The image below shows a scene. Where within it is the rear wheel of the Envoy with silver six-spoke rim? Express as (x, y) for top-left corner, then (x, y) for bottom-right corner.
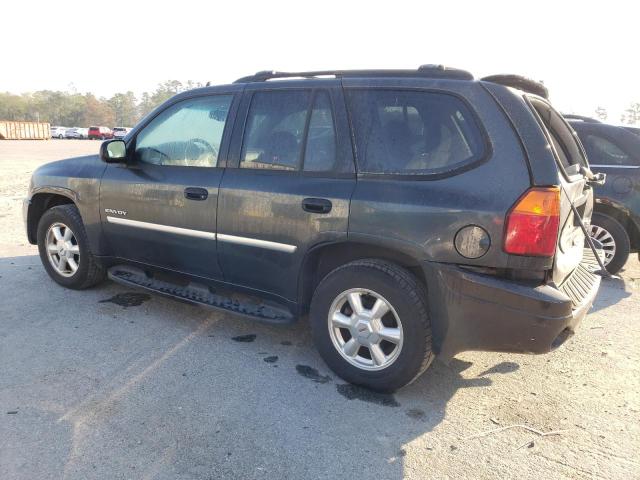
(309, 259), (434, 392)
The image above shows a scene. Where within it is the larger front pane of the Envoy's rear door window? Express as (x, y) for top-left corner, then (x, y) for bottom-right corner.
(240, 90), (311, 170)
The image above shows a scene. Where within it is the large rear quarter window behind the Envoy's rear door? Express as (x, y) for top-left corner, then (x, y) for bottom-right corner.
(348, 89), (485, 175)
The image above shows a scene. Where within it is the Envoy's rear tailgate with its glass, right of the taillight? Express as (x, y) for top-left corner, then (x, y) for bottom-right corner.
(528, 97), (594, 285)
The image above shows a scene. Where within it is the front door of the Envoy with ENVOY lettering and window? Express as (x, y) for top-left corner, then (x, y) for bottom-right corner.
(100, 94), (234, 279)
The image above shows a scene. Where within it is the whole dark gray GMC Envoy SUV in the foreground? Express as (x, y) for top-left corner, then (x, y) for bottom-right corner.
(25, 66), (600, 391)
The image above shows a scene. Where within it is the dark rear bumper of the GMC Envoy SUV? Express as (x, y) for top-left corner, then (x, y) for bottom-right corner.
(424, 251), (600, 360)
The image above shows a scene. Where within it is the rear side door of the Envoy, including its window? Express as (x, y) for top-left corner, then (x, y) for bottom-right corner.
(218, 80), (355, 301)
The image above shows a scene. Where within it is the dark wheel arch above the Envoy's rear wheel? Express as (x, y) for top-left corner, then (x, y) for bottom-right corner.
(298, 241), (427, 314)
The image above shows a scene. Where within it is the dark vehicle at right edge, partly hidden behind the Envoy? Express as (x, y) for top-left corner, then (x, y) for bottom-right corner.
(567, 115), (640, 274)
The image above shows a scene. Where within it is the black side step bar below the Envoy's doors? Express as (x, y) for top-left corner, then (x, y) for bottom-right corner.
(108, 265), (295, 324)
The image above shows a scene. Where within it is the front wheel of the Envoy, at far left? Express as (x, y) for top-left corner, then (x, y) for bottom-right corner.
(37, 205), (106, 290)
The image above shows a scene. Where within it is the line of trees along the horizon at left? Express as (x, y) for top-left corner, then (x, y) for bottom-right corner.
(0, 80), (202, 127)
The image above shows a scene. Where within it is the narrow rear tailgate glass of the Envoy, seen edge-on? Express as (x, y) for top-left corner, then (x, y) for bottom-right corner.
(529, 97), (586, 176)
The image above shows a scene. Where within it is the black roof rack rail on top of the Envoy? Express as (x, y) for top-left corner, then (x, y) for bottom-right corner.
(233, 65), (473, 83)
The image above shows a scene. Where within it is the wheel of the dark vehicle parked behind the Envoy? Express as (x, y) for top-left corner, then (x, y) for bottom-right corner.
(590, 213), (631, 275)
